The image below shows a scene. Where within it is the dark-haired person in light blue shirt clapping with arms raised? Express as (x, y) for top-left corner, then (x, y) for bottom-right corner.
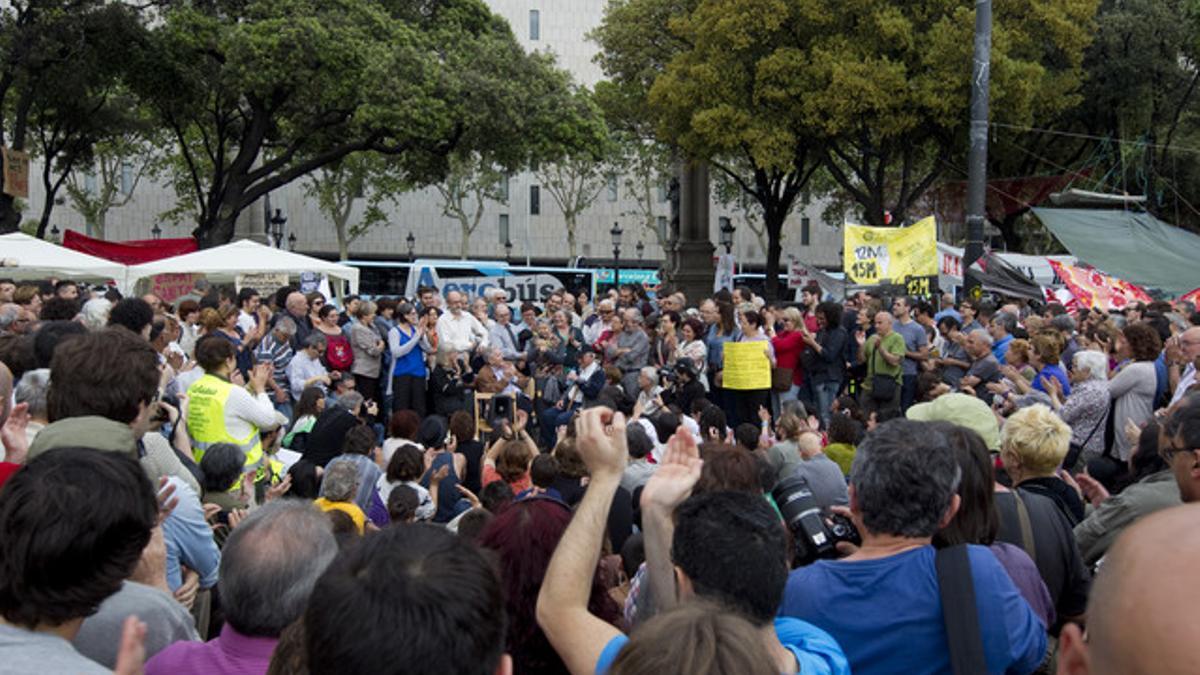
(538, 408), (850, 675)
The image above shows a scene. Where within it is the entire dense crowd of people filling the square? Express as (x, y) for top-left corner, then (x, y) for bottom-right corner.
(0, 269), (1200, 675)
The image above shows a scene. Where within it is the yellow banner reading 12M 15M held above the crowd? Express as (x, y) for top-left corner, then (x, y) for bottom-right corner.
(842, 216), (938, 286)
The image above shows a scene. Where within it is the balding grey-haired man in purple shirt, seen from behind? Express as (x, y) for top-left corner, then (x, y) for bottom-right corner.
(145, 500), (337, 675)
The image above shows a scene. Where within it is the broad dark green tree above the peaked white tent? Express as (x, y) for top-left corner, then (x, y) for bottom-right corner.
(138, 0), (576, 246)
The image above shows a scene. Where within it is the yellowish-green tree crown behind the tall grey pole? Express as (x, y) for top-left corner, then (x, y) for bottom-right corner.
(801, 0), (1097, 226)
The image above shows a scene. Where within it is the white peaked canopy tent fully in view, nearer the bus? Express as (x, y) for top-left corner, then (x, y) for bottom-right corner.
(126, 239), (359, 293)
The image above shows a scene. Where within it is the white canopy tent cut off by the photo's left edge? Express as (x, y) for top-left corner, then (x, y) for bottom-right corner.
(0, 232), (127, 283)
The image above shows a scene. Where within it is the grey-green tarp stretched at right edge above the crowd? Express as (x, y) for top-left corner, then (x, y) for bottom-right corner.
(1033, 208), (1200, 295)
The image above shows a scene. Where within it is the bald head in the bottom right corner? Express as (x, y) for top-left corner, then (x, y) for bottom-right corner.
(1057, 504), (1200, 675)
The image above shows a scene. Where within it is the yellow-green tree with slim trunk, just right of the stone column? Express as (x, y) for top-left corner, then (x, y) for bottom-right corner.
(619, 0), (820, 298)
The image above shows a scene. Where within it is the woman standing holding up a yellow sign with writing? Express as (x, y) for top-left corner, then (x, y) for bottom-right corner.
(724, 309), (775, 428)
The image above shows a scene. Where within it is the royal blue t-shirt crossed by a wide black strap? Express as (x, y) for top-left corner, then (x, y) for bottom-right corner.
(780, 545), (1046, 675)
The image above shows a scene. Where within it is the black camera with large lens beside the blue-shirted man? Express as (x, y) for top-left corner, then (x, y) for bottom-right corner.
(770, 476), (863, 567)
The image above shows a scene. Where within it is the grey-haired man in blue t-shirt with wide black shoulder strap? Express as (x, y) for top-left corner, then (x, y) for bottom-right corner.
(780, 419), (1046, 674)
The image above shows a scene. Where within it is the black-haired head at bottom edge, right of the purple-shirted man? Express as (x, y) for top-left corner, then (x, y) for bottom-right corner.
(304, 525), (512, 675)
